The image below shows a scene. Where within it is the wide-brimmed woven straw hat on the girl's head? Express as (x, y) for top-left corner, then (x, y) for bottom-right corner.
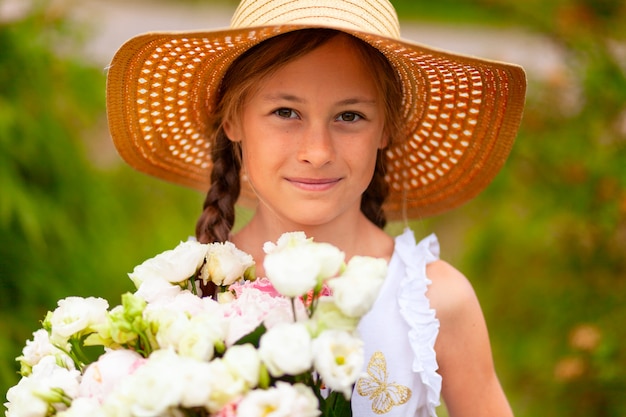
(107, 0), (526, 219)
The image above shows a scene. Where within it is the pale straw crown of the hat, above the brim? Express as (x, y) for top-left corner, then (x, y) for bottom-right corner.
(231, 0), (400, 39)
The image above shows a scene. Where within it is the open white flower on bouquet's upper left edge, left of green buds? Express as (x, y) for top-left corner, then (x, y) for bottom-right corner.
(44, 297), (109, 346)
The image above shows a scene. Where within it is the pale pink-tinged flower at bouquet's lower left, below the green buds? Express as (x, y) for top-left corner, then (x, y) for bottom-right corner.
(79, 349), (147, 403)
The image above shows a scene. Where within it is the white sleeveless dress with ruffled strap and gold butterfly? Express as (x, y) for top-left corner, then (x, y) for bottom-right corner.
(351, 229), (441, 417)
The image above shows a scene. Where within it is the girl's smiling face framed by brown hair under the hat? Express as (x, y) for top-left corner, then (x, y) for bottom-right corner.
(224, 35), (387, 228)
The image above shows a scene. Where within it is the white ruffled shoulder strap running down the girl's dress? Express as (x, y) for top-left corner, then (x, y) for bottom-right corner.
(396, 228), (441, 416)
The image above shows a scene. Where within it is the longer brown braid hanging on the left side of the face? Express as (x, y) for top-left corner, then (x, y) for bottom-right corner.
(196, 129), (241, 243)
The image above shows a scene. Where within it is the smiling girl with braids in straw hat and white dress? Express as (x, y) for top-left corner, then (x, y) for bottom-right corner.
(107, 0), (525, 417)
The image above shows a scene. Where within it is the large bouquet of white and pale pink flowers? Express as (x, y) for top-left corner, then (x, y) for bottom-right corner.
(5, 232), (387, 417)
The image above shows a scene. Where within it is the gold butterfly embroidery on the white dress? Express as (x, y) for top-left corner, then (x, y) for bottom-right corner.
(356, 352), (411, 414)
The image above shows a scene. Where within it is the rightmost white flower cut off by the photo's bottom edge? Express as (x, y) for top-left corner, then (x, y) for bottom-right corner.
(237, 381), (321, 417)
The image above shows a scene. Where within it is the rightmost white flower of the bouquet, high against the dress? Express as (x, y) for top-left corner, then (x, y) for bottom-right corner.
(328, 256), (387, 317)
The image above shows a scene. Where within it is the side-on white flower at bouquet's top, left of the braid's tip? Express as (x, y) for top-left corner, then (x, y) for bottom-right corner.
(128, 240), (207, 288)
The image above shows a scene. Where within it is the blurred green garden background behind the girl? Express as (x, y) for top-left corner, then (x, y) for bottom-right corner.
(0, 0), (626, 417)
